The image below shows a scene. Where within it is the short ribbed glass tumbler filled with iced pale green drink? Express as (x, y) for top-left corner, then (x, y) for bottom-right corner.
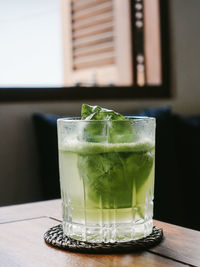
(58, 105), (155, 242)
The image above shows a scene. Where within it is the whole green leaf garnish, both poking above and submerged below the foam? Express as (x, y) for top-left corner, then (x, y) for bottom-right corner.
(78, 104), (154, 211)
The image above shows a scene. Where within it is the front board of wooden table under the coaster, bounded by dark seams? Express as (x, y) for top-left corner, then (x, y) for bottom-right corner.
(0, 218), (185, 267)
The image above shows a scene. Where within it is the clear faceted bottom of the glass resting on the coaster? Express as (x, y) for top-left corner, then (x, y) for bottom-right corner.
(63, 219), (153, 243)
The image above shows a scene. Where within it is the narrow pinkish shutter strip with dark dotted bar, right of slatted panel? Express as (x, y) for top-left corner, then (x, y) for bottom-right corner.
(133, 0), (163, 86)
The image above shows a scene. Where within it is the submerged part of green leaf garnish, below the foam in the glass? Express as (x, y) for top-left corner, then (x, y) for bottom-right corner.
(78, 152), (153, 208)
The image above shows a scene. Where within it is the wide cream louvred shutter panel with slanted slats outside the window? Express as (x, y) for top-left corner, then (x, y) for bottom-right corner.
(62, 0), (133, 86)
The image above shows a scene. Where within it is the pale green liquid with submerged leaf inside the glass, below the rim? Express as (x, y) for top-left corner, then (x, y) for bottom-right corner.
(59, 142), (155, 226)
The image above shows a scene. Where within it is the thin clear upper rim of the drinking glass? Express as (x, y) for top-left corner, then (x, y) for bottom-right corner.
(57, 116), (156, 122)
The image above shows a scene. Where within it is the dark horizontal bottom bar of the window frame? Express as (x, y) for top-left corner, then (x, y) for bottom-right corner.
(0, 84), (170, 102)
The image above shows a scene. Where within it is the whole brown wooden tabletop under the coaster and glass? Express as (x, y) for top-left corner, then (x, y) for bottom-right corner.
(0, 200), (200, 267)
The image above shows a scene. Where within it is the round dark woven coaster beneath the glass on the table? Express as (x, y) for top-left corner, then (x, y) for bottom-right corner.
(44, 224), (163, 253)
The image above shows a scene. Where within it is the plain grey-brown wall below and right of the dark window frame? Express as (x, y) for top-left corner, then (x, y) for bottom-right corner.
(0, 0), (200, 205)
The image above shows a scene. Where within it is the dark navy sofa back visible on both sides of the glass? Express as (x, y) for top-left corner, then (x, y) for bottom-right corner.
(33, 107), (200, 230)
